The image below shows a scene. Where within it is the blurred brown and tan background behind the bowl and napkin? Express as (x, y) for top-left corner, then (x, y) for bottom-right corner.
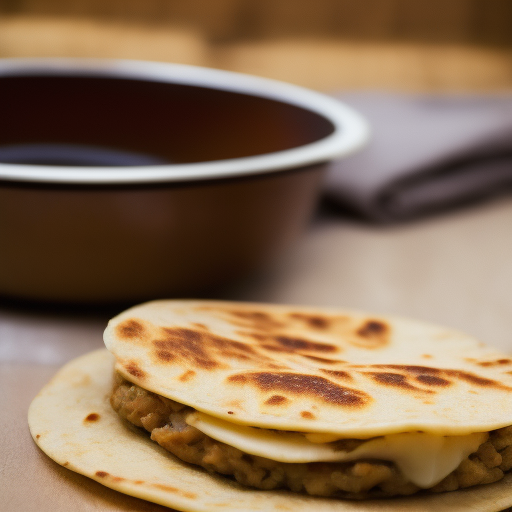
(0, 0), (512, 92)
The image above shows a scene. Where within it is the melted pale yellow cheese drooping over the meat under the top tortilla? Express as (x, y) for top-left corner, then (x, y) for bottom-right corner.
(186, 411), (488, 489)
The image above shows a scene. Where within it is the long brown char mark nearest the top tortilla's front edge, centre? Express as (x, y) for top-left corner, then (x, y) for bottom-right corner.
(228, 372), (371, 407)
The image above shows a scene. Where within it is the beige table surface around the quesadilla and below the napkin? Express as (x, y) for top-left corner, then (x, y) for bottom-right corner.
(0, 197), (512, 512)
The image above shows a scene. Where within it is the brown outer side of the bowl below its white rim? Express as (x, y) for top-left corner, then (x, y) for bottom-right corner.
(0, 165), (324, 303)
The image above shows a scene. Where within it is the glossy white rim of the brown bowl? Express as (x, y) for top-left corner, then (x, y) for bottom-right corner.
(0, 58), (369, 184)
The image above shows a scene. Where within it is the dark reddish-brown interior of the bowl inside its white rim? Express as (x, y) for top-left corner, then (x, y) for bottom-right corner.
(0, 75), (334, 165)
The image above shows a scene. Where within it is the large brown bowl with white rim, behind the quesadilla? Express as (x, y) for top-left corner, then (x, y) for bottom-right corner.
(0, 59), (367, 303)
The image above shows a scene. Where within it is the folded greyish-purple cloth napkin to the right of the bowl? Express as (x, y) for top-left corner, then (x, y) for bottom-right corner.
(325, 92), (512, 222)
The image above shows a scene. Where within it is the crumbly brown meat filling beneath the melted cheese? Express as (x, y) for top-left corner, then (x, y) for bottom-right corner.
(110, 373), (512, 499)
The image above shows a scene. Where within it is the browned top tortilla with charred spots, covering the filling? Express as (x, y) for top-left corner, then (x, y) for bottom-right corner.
(104, 301), (512, 438)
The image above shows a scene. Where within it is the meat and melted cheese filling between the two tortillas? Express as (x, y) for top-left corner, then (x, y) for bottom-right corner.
(111, 374), (512, 498)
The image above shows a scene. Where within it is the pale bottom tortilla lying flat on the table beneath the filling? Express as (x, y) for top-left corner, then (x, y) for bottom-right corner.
(28, 350), (512, 512)
